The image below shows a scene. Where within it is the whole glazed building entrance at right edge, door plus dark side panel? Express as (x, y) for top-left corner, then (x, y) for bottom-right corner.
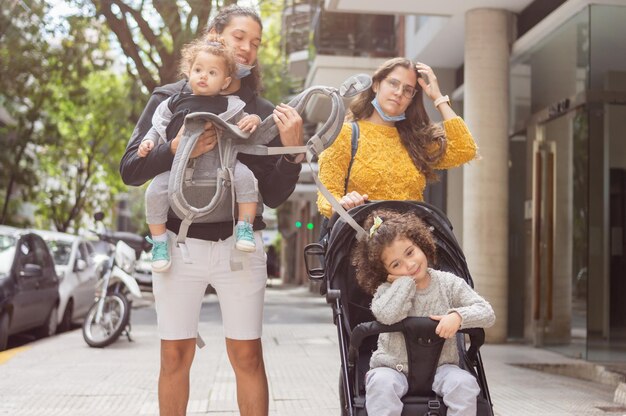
(524, 100), (626, 362)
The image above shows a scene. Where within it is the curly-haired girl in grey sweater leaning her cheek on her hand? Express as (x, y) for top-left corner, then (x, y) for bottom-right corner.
(353, 210), (495, 416)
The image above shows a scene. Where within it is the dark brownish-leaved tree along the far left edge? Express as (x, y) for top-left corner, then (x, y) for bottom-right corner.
(0, 1), (54, 225)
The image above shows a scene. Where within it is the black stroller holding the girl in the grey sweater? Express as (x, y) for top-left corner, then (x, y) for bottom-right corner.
(304, 201), (493, 416)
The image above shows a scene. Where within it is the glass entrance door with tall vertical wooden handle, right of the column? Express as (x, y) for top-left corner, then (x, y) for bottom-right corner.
(527, 106), (589, 357)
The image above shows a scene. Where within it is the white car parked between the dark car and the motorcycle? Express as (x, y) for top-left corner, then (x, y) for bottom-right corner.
(33, 230), (98, 332)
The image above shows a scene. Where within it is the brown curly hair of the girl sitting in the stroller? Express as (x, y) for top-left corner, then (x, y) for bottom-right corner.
(352, 209), (437, 295)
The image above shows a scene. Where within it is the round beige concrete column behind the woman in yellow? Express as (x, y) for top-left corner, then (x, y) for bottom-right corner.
(463, 9), (513, 342)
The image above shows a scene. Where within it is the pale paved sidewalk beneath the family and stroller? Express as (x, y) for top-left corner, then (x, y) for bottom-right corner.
(0, 288), (626, 416)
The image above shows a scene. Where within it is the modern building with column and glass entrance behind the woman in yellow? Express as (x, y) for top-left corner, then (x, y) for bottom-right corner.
(279, 0), (626, 362)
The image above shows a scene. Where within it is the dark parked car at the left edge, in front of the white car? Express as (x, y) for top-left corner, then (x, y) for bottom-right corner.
(0, 226), (59, 351)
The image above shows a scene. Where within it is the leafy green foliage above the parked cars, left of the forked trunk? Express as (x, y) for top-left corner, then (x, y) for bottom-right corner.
(0, 1), (143, 231)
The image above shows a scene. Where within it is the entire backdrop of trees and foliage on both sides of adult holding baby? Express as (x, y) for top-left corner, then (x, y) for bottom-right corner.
(0, 0), (298, 231)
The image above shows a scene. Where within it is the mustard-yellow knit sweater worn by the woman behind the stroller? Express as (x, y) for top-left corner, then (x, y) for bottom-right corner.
(317, 117), (477, 217)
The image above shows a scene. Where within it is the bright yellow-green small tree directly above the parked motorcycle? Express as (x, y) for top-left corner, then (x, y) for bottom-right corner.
(37, 70), (132, 231)
